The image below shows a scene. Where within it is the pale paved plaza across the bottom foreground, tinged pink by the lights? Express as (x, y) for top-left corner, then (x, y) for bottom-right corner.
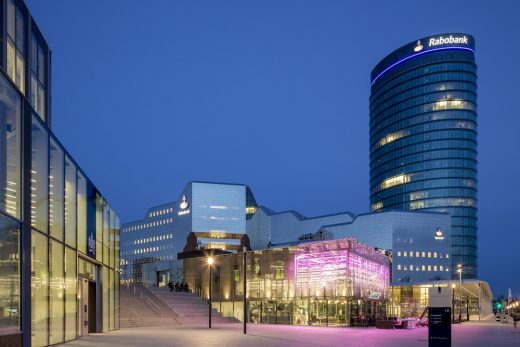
(62, 322), (520, 347)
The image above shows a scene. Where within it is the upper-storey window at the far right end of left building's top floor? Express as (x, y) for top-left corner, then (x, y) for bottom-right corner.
(29, 33), (47, 121)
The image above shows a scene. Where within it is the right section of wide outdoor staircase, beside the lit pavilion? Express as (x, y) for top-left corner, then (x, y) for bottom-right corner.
(149, 288), (238, 325)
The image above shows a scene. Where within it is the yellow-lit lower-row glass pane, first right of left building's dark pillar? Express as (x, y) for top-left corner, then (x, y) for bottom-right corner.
(31, 231), (49, 347)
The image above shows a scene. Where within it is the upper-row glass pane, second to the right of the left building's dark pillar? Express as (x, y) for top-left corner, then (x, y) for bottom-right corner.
(49, 139), (65, 241)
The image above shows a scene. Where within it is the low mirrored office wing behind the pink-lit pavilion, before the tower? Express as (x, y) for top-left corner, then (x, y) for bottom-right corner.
(248, 207), (451, 285)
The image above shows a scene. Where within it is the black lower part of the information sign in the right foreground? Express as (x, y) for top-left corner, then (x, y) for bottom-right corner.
(428, 307), (451, 347)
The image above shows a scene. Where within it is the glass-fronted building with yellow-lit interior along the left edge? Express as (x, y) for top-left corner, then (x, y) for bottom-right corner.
(0, 0), (119, 346)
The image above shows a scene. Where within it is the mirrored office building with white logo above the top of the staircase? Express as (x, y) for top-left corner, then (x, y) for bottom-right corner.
(121, 181), (256, 286)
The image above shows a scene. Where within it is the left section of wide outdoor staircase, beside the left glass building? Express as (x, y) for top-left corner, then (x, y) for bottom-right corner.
(119, 286), (180, 328)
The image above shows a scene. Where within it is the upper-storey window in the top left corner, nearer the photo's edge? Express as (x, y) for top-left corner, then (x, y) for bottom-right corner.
(7, 0), (25, 94)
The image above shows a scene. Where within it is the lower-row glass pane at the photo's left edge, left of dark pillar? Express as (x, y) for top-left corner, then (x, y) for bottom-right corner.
(0, 214), (20, 333)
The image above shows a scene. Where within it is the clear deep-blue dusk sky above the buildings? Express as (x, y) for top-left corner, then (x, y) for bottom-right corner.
(26, 0), (520, 296)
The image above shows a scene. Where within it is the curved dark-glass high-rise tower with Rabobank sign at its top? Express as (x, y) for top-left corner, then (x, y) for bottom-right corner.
(370, 33), (477, 278)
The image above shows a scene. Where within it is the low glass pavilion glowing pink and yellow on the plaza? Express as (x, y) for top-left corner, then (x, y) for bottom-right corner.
(184, 239), (389, 326)
